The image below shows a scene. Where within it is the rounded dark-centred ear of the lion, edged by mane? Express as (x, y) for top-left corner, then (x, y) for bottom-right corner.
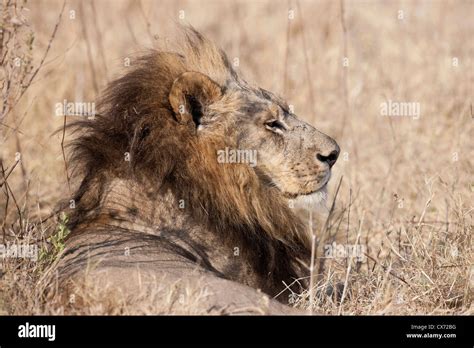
(169, 71), (222, 127)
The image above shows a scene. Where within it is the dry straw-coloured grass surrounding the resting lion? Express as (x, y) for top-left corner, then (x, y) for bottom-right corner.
(0, 0), (474, 314)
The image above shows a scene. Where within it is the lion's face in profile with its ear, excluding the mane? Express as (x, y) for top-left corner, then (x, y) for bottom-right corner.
(169, 72), (339, 199)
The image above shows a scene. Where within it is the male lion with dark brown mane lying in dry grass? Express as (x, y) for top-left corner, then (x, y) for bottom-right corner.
(51, 28), (340, 314)
